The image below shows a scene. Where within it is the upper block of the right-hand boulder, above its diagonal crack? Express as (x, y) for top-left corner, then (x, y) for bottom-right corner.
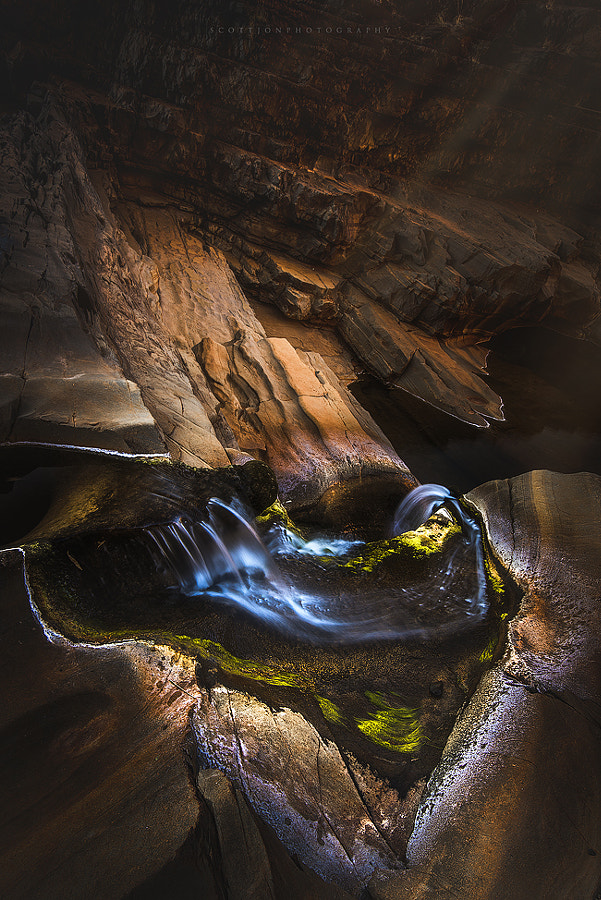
(469, 471), (601, 704)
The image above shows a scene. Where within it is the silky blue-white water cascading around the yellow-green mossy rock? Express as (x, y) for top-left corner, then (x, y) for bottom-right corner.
(147, 485), (487, 643)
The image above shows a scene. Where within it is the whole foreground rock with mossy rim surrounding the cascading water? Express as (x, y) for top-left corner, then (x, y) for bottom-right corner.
(2, 454), (601, 900)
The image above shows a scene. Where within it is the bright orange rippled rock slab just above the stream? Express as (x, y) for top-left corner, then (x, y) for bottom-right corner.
(198, 332), (411, 506)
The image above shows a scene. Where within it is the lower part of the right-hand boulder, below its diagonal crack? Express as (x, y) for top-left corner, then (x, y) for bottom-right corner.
(370, 669), (601, 900)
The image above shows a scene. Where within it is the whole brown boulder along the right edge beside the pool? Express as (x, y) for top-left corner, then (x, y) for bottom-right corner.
(370, 472), (601, 900)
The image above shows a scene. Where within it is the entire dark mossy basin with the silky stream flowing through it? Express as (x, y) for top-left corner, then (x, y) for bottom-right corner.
(12, 451), (506, 796)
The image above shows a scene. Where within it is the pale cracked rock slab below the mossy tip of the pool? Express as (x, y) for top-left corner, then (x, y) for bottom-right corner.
(194, 687), (400, 894)
